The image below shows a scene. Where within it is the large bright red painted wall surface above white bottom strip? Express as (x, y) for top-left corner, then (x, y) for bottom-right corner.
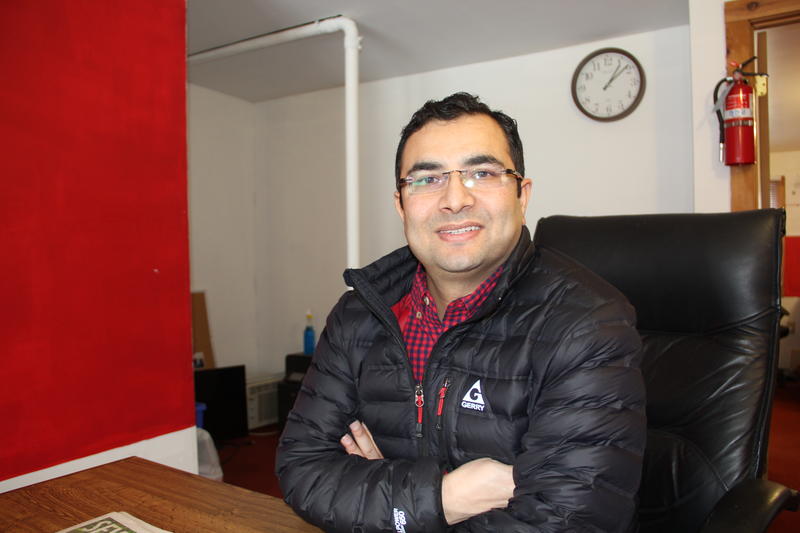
(0, 0), (194, 479)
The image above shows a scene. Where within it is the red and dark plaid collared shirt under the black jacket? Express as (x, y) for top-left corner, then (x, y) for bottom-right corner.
(392, 265), (503, 383)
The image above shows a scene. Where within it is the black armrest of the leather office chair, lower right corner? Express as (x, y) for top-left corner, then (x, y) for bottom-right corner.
(701, 479), (800, 533)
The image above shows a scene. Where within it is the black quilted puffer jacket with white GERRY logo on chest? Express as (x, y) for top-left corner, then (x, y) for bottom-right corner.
(276, 228), (645, 533)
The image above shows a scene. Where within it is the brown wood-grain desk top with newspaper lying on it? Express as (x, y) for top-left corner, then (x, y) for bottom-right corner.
(0, 457), (320, 533)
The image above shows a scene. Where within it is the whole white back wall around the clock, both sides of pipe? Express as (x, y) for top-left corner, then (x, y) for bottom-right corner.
(255, 26), (692, 372)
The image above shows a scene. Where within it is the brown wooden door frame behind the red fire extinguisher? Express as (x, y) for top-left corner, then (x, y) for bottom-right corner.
(725, 0), (800, 211)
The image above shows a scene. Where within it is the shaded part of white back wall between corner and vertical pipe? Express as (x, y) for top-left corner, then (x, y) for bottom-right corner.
(255, 93), (346, 373)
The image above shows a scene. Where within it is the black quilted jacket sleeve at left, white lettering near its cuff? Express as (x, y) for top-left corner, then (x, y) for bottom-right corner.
(276, 297), (447, 533)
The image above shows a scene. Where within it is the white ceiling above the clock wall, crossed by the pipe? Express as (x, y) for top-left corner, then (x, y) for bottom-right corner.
(188, 0), (689, 102)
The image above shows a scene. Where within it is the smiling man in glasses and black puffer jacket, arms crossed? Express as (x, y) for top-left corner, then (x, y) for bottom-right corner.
(276, 93), (645, 533)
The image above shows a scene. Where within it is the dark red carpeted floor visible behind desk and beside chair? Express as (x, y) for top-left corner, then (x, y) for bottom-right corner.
(219, 382), (800, 533)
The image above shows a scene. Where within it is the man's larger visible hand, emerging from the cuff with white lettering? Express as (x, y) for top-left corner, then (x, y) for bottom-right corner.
(442, 457), (514, 525)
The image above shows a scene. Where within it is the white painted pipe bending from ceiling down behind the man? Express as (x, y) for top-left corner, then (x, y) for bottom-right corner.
(189, 16), (361, 268)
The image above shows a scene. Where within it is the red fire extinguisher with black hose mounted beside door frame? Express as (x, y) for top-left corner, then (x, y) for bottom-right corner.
(714, 57), (766, 165)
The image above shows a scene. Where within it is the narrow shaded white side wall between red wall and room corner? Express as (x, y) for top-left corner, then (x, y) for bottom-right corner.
(188, 85), (258, 375)
